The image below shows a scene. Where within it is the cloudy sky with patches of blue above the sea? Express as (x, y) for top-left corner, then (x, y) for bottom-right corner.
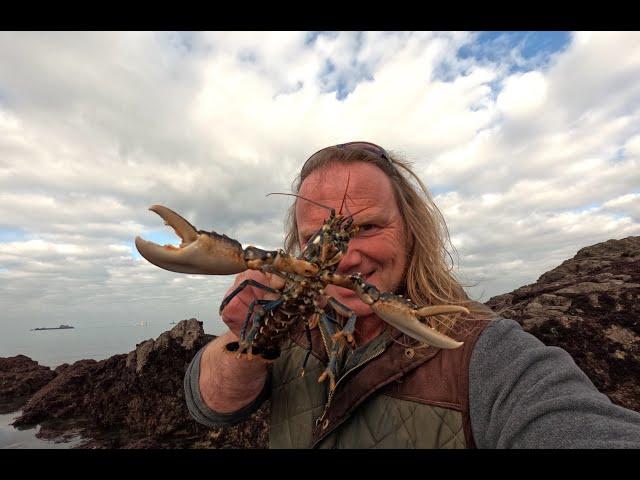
(0, 32), (640, 333)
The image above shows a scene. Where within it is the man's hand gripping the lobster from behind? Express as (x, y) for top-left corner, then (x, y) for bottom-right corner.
(221, 270), (284, 338)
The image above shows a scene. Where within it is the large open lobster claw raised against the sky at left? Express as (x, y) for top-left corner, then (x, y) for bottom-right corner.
(136, 205), (247, 275)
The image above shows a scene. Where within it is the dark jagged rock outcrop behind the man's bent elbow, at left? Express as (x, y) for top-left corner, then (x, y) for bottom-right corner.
(14, 319), (269, 448)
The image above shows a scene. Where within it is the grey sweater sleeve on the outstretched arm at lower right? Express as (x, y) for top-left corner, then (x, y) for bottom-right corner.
(469, 320), (640, 448)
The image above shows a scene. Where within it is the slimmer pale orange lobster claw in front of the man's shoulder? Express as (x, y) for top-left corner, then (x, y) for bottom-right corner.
(371, 293), (469, 349)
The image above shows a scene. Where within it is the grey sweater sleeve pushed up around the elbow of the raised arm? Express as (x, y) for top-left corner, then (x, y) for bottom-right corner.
(184, 345), (271, 427)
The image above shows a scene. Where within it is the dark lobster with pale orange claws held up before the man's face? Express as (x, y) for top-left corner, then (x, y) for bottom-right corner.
(135, 197), (469, 392)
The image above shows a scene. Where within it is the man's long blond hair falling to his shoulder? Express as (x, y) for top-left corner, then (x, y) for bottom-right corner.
(284, 147), (495, 332)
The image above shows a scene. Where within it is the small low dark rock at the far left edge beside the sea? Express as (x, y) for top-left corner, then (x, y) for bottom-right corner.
(0, 355), (56, 414)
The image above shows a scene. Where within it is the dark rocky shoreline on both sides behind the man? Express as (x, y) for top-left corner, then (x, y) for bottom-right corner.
(0, 237), (640, 448)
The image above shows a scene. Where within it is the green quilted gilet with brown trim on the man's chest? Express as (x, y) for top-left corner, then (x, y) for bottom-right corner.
(269, 321), (487, 448)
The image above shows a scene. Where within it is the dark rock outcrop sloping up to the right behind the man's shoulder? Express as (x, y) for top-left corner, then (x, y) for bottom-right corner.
(486, 237), (640, 412)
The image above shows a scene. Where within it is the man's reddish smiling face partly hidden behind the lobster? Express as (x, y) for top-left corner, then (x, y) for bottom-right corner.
(296, 162), (407, 317)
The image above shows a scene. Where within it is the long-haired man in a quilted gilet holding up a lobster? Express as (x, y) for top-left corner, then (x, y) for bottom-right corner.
(185, 142), (640, 448)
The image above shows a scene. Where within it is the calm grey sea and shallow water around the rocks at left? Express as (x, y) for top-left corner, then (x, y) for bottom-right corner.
(0, 320), (225, 449)
